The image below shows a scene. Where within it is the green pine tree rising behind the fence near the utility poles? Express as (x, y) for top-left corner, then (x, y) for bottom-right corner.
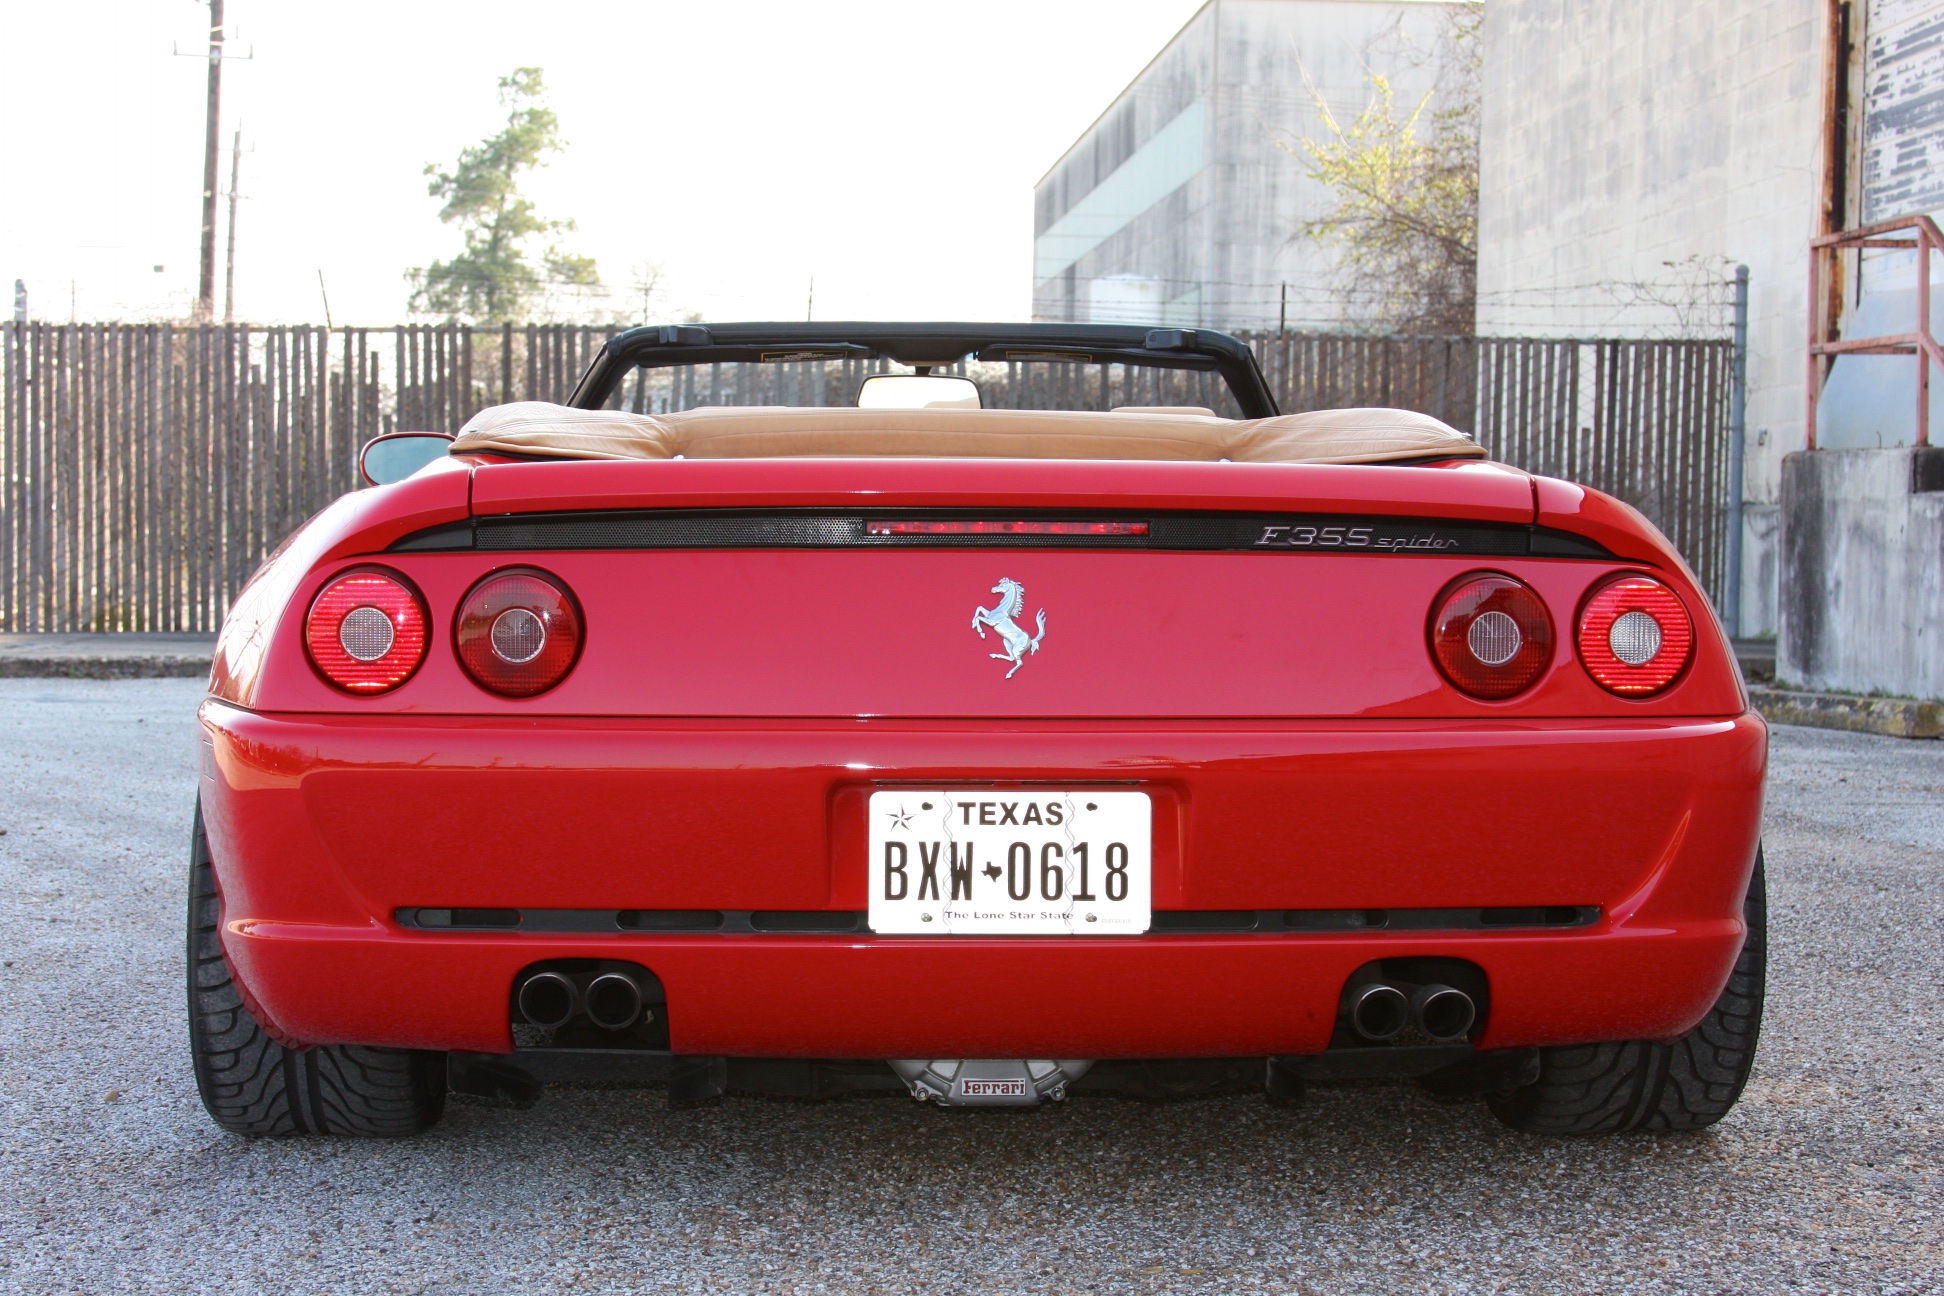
(412, 68), (601, 323)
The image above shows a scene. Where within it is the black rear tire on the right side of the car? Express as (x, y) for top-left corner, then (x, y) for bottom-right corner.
(1487, 849), (1769, 1135)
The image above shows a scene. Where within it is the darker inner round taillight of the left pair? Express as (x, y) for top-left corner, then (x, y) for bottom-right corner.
(453, 569), (581, 698)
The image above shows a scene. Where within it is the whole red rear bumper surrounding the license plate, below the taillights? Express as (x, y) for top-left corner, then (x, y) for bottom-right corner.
(202, 701), (1765, 1057)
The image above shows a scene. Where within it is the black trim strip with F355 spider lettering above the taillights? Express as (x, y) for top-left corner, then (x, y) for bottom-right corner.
(391, 509), (1614, 560)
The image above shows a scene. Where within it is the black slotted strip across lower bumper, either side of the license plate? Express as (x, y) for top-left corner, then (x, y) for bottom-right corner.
(397, 905), (1600, 937)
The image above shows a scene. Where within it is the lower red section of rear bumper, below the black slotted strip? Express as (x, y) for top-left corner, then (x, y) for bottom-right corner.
(224, 921), (1742, 1057)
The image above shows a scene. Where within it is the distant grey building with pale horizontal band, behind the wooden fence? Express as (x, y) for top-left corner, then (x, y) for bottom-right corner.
(1032, 0), (1450, 328)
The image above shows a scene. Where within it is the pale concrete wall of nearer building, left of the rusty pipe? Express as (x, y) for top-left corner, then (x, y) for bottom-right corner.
(1477, 0), (1823, 633)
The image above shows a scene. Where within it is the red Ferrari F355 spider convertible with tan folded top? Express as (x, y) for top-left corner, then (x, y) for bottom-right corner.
(189, 324), (1767, 1135)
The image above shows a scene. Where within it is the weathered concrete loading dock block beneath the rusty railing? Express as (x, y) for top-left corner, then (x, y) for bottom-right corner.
(1775, 447), (1944, 698)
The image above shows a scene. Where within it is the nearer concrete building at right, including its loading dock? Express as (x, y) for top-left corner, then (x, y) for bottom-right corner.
(1477, 0), (1944, 696)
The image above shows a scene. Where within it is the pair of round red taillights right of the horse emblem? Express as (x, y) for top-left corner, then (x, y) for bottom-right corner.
(1431, 571), (1695, 701)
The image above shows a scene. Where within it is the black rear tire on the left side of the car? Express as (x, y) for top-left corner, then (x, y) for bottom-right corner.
(189, 804), (445, 1139)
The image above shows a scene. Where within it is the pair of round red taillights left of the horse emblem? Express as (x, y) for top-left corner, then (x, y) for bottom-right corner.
(303, 567), (581, 698)
